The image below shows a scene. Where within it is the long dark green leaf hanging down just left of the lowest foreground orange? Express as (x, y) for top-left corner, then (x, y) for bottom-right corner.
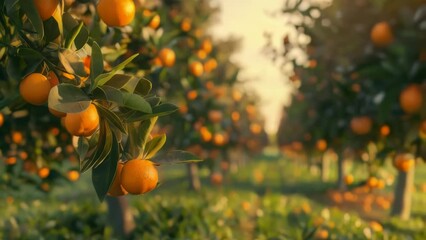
(92, 132), (120, 201)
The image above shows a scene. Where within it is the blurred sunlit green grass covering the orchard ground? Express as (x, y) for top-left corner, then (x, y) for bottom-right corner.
(0, 147), (426, 239)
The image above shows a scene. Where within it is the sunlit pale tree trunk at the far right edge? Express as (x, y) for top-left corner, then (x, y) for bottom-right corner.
(391, 168), (414, 220)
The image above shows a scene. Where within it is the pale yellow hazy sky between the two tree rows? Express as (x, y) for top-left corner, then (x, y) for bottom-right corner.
(212, 0), (290, 133)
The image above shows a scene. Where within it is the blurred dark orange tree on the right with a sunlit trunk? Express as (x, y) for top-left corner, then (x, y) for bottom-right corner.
(272, 1), (424, 218)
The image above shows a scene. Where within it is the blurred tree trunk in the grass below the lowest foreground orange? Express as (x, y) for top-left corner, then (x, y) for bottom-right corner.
(105, 196), (136, 238)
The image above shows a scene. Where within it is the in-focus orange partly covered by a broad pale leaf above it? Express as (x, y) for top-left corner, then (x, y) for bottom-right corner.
(65, 103), (99, 137)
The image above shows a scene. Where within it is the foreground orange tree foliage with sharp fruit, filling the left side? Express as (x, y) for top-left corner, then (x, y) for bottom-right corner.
(0, 0), (201, 204)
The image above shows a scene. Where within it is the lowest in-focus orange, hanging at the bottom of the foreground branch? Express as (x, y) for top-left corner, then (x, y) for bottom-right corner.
(121, 159), (158, 194)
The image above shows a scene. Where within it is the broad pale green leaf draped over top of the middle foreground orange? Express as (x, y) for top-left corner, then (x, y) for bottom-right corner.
(48, 83), (91, 113)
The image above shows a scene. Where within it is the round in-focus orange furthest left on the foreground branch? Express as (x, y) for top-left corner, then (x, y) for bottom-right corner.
(19, 73), (51, 105)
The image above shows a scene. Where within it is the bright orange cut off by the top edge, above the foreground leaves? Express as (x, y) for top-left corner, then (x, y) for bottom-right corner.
(96, 0), (136, 27)
